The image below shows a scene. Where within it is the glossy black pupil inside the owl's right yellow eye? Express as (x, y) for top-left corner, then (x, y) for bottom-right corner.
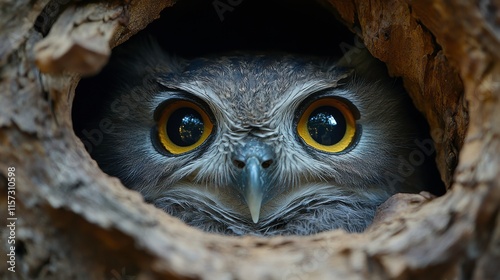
(307, 106), (347, 146)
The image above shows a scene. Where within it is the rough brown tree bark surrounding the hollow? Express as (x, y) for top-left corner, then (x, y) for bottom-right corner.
(0, 0), (500, 279)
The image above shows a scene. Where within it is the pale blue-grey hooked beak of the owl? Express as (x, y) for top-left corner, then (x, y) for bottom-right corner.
(243, 157), (264, 223)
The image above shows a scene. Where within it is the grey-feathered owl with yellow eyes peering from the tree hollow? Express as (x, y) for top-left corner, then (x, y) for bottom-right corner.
(77, 36), (440, 236)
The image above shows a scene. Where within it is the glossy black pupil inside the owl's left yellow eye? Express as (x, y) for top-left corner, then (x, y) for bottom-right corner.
(167, 108), (204, 147)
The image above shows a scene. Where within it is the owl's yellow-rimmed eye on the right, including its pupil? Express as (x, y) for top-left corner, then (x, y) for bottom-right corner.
(297, 97), (356, 153)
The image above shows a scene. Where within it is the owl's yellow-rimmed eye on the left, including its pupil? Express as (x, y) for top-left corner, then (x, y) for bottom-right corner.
(158, 100), (213, 155)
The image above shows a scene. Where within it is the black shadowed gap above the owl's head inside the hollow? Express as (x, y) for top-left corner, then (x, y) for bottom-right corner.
(147, 0), (352, 58)
